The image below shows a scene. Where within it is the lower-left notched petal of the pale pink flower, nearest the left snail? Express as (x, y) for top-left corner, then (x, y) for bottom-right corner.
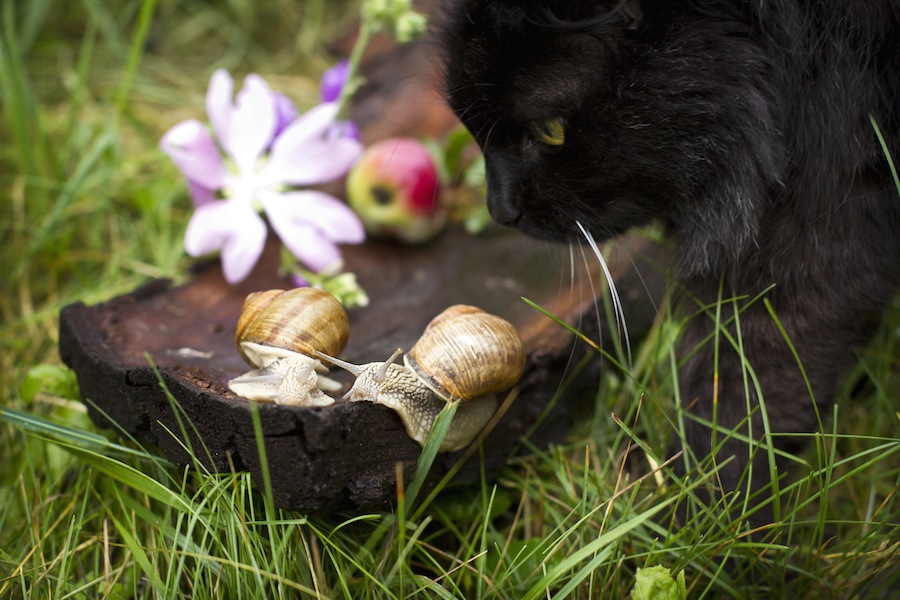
(184, 201), (266, 284)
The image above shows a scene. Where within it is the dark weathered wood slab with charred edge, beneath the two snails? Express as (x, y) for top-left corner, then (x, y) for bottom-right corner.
(59, 24), (653, 512)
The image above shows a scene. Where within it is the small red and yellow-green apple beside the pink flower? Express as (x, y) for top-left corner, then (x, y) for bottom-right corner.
(347, 137), (447, 244)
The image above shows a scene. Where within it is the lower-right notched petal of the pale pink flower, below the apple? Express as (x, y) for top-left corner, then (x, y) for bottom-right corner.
(260, 191), (365, 272)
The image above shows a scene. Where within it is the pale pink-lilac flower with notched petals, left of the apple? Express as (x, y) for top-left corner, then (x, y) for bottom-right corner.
(161, 70), (365, 283)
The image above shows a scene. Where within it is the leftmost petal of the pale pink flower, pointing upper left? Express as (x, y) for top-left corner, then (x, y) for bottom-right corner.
(159, 119), (226, 190)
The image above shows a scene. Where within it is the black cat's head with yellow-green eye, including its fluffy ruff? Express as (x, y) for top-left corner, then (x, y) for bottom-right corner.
(443, 0), (776, 270)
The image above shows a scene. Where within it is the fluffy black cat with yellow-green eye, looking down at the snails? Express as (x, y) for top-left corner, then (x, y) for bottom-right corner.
(441, 0), (900, 522)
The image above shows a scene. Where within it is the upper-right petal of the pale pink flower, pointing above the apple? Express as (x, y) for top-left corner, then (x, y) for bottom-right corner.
(260, 104), (363, 185)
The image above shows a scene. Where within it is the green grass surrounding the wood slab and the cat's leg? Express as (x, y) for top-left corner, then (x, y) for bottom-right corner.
(0, 0), (900, 599)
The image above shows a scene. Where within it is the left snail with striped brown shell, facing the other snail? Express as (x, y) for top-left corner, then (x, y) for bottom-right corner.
(228, 288), (350, 406)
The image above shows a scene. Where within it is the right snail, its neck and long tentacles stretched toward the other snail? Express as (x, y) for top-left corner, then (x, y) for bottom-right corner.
(314, 305), (525, 452)
